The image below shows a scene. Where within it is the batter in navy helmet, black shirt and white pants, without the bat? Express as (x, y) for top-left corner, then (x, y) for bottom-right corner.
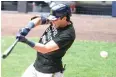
(16, 4), (75, 77)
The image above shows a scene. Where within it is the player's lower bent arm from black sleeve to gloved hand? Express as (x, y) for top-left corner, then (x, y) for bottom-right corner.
(17, 34), (73, 54)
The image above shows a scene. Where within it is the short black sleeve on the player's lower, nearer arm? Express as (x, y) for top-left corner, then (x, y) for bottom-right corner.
(53, 34), (73, 48)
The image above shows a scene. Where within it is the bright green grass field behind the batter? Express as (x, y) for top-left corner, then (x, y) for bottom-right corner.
(1, 37), (116, 77)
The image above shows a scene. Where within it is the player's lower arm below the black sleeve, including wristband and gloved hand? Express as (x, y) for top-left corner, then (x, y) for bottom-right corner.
(17, 35), (59, 54)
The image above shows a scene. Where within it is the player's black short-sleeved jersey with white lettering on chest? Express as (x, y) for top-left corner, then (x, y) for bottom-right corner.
(34, 21), (75, 73)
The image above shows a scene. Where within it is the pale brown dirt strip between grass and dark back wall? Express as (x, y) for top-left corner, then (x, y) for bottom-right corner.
(1, 12), (116, 42)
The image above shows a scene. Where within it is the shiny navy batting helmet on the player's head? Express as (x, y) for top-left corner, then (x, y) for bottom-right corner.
(48, 4), (71, 20)
